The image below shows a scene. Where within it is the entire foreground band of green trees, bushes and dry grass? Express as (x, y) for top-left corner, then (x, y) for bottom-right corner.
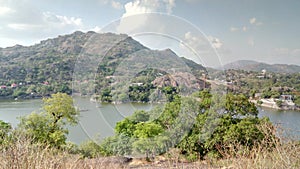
(0, 90), (300, 168)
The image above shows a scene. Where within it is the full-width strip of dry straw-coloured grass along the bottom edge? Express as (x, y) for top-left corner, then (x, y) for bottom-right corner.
(0, 123), (300, 169)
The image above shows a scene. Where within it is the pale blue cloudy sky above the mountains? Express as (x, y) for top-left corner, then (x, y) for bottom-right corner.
(0, 0), (300, 67)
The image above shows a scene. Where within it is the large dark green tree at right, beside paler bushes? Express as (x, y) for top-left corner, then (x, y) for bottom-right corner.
(178, 91), (272, 160)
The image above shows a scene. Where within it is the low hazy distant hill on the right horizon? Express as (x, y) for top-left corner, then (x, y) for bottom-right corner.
(224, 60), (300, 73)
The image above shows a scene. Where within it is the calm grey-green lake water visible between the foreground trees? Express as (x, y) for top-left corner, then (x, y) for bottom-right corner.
(0, 97), (300, 143)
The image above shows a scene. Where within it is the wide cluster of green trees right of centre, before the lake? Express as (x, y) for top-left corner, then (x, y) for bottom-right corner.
(102, 90), (273, 160)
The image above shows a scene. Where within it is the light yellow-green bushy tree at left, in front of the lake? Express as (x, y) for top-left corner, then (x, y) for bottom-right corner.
(18, 93), (79, 148)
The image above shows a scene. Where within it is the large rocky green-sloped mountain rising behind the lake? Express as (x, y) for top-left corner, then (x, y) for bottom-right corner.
(0, 31), (206, 97)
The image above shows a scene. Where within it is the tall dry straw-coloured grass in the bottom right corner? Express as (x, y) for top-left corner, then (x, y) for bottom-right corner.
(214, 125), (300, 169)
